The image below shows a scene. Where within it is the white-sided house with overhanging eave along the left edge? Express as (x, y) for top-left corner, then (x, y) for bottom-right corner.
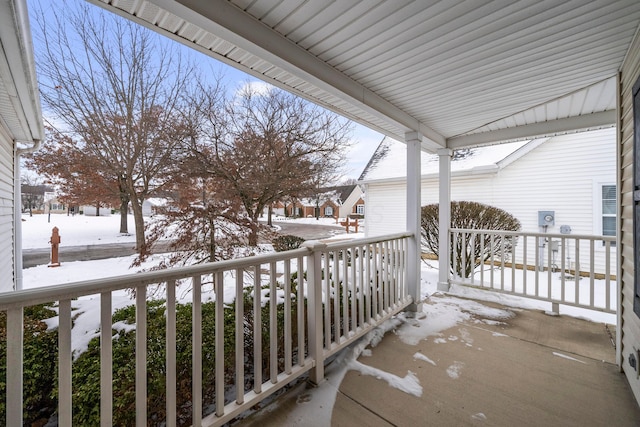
(0, 1), (44, 292)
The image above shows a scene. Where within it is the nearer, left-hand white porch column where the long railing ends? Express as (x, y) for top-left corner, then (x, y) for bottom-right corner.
(404, 132), (422, 312)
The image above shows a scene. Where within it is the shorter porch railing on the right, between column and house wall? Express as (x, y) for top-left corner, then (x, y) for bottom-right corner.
(450, 229), (617, 313)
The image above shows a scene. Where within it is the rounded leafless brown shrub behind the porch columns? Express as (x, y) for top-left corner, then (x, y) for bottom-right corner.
(420, 201), (520, 277)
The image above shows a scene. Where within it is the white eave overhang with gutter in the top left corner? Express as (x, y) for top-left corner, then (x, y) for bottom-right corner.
(0, 0), (44, 144)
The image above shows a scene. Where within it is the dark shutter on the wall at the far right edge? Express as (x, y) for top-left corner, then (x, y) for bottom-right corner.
(633, 78), (640, 316)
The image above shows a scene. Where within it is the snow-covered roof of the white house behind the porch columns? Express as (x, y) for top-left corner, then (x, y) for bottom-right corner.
(359, 137), (548, 182)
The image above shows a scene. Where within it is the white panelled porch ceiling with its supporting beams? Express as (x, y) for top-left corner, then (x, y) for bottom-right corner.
(89, 0), (640, 150)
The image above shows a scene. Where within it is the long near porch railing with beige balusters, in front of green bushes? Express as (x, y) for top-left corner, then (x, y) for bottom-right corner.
(0, 233), (411, 426)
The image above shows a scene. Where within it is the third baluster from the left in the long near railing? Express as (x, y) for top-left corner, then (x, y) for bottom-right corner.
(100, 292), (113, 427)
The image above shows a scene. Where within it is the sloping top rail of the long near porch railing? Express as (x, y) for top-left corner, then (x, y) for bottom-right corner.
(0, 232), (412, 311)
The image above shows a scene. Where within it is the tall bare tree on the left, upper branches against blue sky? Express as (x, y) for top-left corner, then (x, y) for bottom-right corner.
(35, 0), (193, 251)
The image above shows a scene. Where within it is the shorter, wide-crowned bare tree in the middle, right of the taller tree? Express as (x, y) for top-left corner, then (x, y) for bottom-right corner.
(192, 86), (351, 246)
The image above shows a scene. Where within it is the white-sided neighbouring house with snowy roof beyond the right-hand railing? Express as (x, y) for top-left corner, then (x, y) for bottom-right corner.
(360, 128), (616, 272)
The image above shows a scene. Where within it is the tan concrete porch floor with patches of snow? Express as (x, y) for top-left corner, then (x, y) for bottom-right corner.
(236, 296), (640, 426)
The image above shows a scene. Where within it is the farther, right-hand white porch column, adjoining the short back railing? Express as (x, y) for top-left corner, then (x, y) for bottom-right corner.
(438, 148), (453, 292)
